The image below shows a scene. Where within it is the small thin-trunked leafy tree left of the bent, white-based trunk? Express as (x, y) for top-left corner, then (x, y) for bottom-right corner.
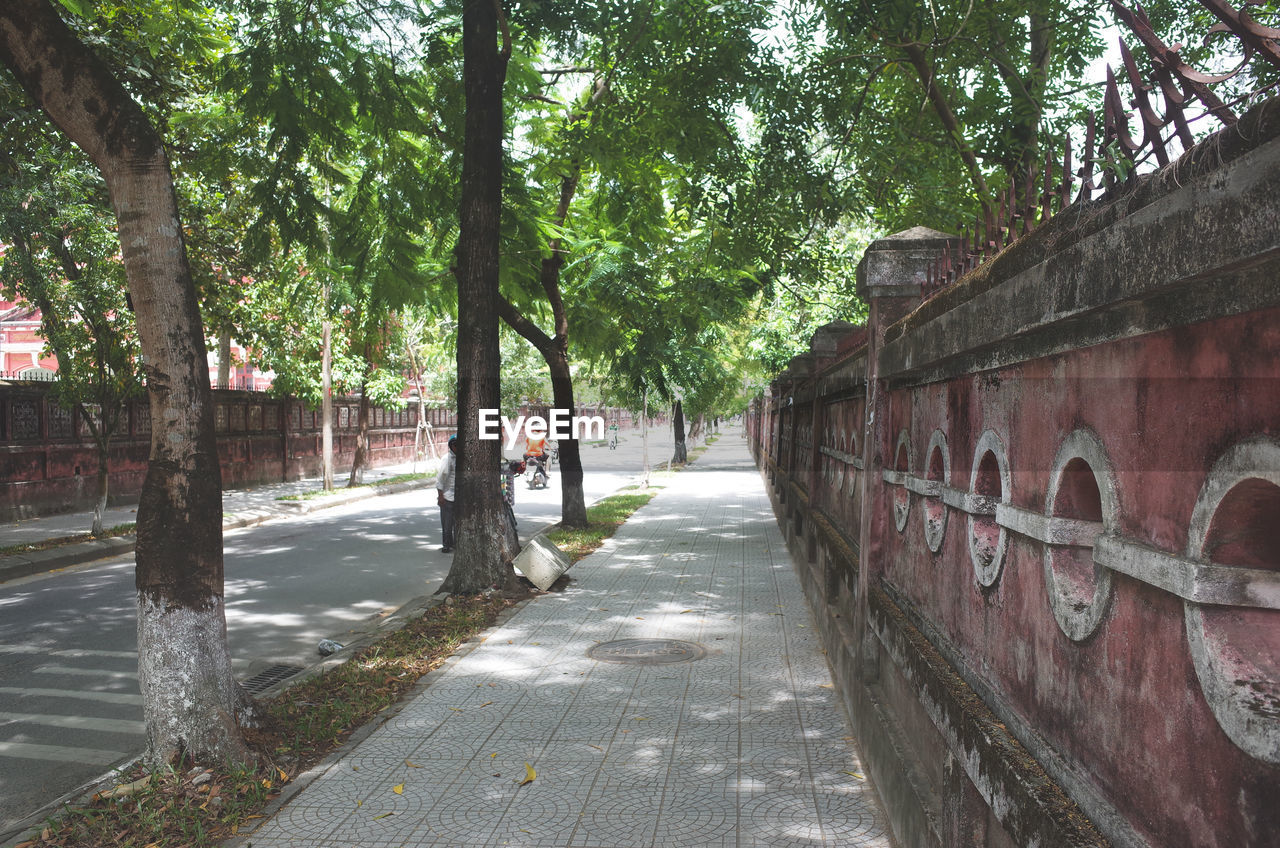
(0, 154), (142, 535)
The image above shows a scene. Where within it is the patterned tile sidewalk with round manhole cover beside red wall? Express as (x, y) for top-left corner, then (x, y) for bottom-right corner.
(232, 434), (892, 848)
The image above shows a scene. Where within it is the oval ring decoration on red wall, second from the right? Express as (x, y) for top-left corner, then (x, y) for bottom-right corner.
(1044, 429), (1120, 642)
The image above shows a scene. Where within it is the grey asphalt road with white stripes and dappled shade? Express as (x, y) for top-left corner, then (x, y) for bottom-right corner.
(0, 430), (701, 843)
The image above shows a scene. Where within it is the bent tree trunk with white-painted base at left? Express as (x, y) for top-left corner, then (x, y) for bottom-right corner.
(0, 0), (250, 762)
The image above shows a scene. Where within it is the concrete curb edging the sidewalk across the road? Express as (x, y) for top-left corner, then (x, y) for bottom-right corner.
(0, 478), (435, 583)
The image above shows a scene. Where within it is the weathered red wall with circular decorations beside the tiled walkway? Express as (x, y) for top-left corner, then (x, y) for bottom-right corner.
(751, 102), (1280, 848)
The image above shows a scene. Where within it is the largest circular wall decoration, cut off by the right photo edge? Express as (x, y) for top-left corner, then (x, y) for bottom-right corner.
(1183, 438), (1280, 763)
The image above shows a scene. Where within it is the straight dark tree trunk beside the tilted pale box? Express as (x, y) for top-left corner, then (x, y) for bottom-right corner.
(440, 0), (515, 593)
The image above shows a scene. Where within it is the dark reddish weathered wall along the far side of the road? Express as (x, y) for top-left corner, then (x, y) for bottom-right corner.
(0, 384), (453, 521)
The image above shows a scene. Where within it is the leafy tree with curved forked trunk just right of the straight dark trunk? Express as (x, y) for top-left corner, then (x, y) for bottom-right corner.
(499, 1), (772, 526)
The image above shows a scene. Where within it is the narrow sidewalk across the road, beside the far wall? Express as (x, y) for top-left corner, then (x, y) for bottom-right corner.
(0, 460), (435, 583)
